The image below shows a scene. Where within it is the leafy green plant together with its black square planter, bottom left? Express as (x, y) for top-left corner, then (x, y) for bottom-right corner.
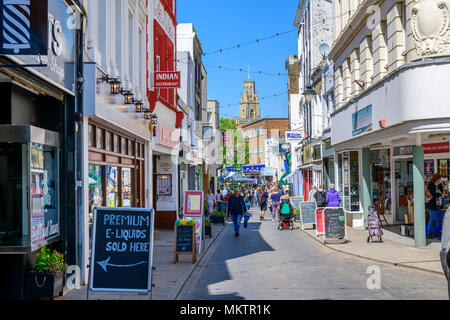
(27, 245), (67, 300)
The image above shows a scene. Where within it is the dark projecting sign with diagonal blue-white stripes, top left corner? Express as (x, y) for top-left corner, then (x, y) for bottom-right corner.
(0, 0), (48, 56)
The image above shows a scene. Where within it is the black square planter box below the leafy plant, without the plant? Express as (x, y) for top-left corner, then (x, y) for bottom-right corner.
(27, 272), (64, 300)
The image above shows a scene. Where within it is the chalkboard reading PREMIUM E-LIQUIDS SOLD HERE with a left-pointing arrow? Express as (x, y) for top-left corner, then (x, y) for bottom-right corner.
(89, 207), (154, 293)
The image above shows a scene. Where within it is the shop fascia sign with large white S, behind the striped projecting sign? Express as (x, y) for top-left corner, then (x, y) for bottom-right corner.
(3, 0), (76, 93)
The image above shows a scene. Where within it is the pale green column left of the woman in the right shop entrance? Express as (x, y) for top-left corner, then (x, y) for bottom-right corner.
(413, 146), (427, 247)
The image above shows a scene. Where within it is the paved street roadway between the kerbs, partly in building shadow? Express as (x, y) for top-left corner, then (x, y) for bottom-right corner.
(178, 209), (448, 300)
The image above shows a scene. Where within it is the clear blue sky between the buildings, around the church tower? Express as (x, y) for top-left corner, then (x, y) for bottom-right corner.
(177, 0), (298, 118)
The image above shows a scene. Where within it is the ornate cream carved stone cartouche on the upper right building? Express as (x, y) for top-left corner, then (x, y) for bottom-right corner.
(411, 0), (450, 60)
